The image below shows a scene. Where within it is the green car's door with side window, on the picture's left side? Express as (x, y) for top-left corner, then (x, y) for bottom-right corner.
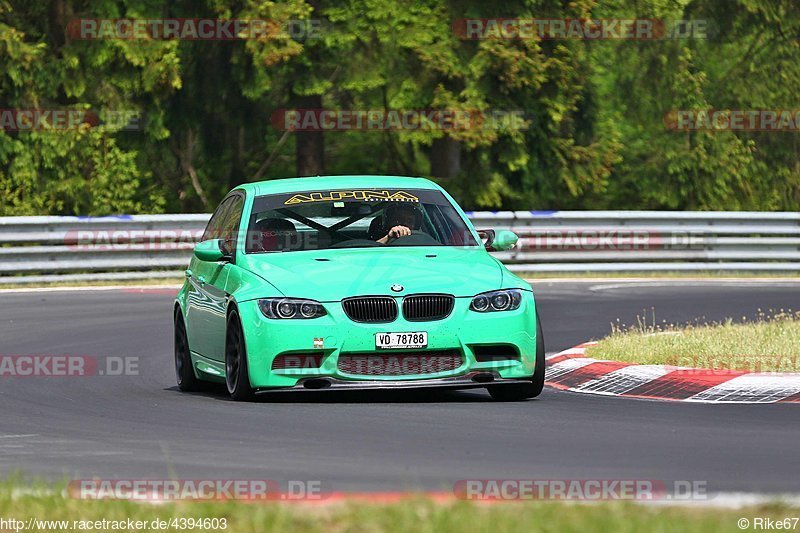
(187, 194), (244, 361)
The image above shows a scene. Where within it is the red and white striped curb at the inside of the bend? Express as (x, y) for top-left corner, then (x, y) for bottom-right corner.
(545, 342), (800, 403)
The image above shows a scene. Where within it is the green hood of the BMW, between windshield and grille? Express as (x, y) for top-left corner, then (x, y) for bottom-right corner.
(242, 246), (503, 302)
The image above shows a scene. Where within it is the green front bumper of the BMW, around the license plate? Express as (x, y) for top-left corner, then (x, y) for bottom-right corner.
(238, 291), (536, 390)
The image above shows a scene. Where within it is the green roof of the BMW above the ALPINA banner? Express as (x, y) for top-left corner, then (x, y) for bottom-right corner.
(231, 175), (441, 196)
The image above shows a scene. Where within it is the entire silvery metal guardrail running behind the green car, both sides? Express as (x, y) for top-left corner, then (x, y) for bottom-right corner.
(0, 211), (800, 284)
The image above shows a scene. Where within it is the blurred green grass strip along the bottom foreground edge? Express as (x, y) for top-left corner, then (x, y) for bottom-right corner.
(0, 490), (798, 533)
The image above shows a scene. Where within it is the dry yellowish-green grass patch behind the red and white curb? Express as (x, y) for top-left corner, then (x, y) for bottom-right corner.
(586, 309), (800, 372)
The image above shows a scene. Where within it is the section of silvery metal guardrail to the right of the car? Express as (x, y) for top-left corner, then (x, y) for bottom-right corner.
(470, 211), (800, 272)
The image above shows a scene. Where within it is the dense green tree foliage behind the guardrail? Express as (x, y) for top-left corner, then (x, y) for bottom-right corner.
(0, 0), (800, 216)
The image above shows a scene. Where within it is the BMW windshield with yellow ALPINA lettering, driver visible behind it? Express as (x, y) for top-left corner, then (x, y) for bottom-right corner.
(246, 188), (478, 253)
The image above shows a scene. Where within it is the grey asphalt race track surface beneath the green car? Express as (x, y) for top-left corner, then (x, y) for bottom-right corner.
(0, 280), (800, 493)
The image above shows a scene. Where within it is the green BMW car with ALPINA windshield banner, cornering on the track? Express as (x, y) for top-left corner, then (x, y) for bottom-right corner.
(174, 176), (545, 400)
